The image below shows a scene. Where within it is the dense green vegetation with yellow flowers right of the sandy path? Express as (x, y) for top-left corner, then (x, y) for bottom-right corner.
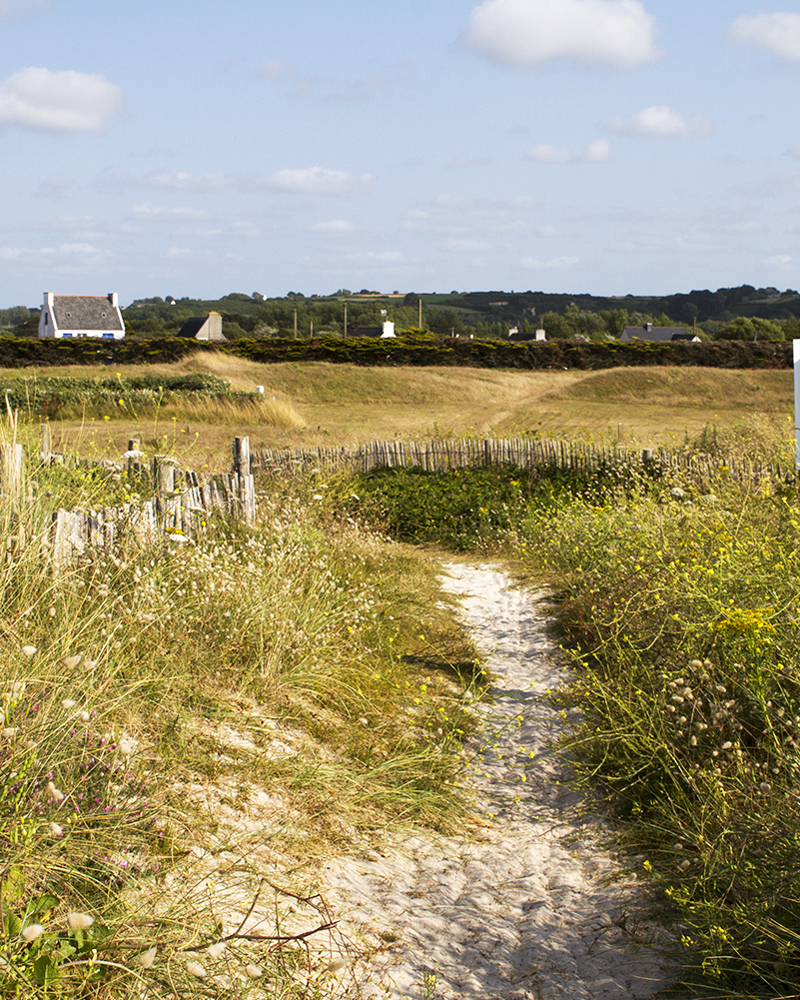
(519, 458), (800, 997)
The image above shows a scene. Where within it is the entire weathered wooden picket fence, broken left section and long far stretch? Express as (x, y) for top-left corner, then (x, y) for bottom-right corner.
(0, 429), (795, 566)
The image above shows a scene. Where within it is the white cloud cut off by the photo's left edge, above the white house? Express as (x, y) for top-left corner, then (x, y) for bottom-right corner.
(0, 66), (122, 132)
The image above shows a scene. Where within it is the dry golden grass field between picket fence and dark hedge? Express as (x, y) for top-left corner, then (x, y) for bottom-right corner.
(6, 354), (792, 468)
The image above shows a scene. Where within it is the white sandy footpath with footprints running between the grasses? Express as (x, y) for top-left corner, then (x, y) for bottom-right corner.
(323, 564), (677, 1000)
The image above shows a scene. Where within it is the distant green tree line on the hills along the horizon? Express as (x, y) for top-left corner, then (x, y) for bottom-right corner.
(6, 285), (800, 342)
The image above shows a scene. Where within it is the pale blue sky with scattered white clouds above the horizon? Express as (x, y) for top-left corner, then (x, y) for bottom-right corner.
(0, 0), (800, 308)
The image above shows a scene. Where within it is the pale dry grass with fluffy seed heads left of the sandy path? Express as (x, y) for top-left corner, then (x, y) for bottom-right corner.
(0, 420), (482, 1000)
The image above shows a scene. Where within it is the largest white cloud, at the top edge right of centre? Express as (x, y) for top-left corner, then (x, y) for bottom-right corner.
(463, 0), (658, 70)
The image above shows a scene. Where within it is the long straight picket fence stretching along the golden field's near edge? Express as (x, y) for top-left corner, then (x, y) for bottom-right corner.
(251, 438), (794, 484)
